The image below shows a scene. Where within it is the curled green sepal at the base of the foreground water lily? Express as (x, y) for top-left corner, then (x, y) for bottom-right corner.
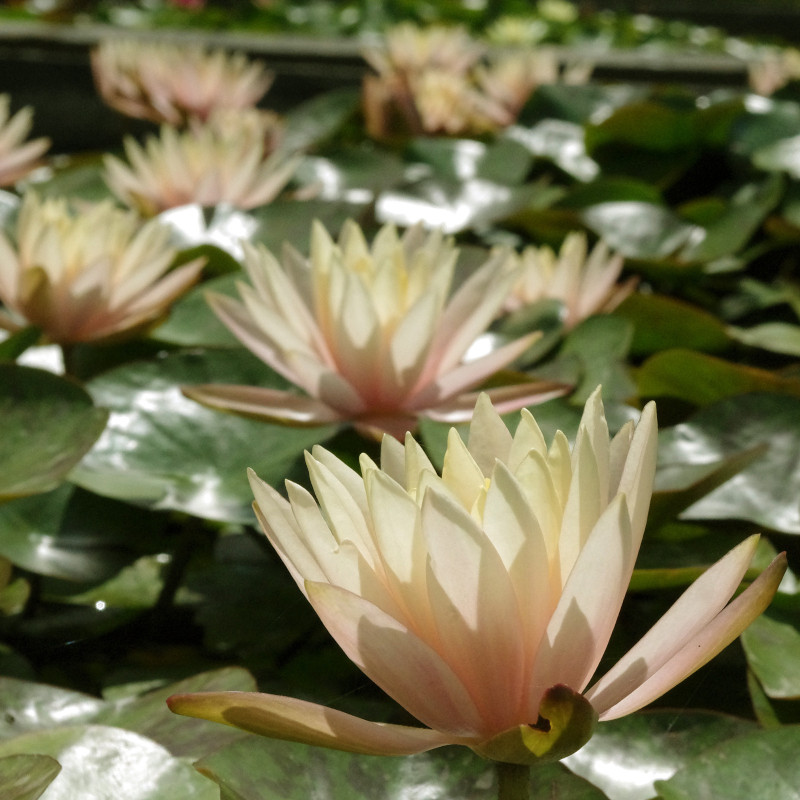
(472, 684), (597, 765)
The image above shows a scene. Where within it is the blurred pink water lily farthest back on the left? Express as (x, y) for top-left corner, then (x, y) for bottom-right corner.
(91, 38), (273, 125)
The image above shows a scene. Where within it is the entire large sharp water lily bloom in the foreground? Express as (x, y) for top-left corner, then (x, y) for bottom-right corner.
(168, 390), (786, 764)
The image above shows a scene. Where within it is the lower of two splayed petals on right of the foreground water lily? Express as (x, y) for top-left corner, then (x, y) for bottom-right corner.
(599, 553), (787, 719)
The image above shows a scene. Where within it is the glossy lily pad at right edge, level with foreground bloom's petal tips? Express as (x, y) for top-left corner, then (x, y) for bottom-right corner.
(659, 394), (800, 534)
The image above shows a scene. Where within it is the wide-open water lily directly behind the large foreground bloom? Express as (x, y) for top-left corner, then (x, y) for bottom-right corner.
(184, 221), (566, 437)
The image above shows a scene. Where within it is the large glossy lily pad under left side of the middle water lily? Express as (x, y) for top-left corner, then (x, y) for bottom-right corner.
(72, 349), (334, 523)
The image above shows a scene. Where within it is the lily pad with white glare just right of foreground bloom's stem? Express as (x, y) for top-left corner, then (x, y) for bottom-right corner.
(564, 710), (755, 800)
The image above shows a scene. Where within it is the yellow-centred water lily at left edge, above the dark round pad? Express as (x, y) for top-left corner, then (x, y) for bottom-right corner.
(0, 192), (203, 344)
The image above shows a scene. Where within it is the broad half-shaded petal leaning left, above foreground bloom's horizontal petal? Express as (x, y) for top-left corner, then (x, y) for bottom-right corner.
(306, 583), (483, 736)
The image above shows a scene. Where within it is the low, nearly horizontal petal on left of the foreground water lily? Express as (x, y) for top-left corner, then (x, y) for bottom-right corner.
(167, 692), (468, 756)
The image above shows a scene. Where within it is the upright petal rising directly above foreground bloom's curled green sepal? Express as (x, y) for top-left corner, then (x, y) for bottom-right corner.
(530, 495), (636, 713)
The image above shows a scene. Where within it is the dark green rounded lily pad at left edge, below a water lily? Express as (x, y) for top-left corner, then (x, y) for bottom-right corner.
(0, 364), (108, 500)
